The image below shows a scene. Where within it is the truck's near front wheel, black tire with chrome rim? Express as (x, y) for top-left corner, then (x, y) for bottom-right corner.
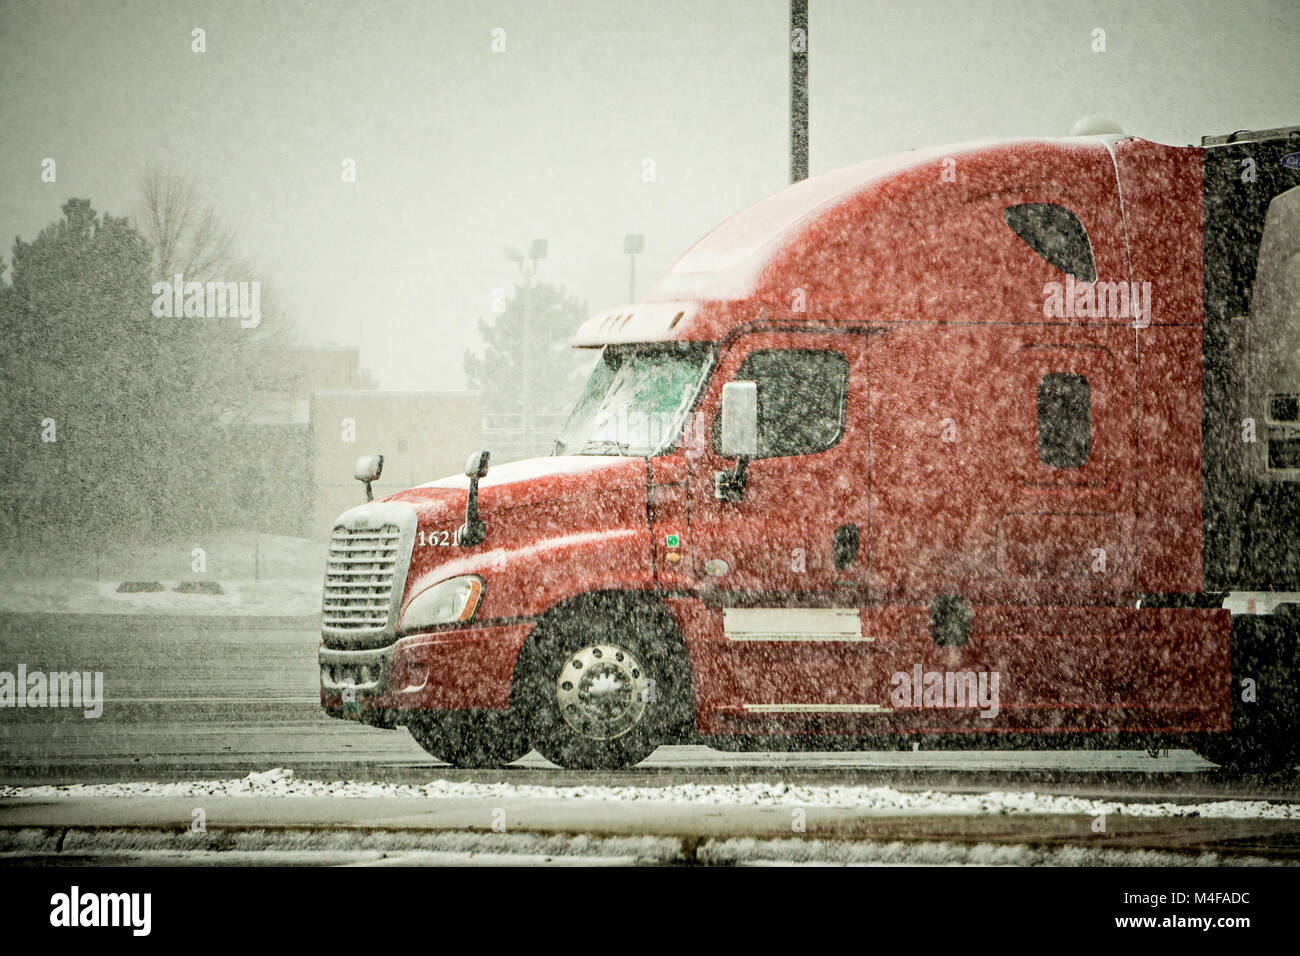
(512, 593), (694, 770)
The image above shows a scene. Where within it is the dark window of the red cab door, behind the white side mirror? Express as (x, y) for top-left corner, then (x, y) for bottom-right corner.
(714, 349), (849, 458)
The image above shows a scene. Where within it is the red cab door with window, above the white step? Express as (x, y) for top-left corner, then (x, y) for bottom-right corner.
(689, 332), (867, 604)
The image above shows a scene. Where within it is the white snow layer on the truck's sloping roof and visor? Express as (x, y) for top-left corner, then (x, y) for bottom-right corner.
(573, 134), (1127, 347)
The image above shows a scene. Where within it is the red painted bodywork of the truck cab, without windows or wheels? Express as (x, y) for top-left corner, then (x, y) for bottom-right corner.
(325, 139), (1230, 735)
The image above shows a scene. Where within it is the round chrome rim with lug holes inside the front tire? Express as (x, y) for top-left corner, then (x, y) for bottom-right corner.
(555, 644), (650, 740)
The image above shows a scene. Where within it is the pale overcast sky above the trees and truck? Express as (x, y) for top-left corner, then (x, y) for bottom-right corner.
(0, 0), (1300, 389)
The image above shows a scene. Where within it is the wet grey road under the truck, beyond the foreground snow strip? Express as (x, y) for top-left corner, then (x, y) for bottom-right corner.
(0, 615), (1300, 803)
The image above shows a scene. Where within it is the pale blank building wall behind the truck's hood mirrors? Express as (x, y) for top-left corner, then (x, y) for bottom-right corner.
(309, 390), (484, 536)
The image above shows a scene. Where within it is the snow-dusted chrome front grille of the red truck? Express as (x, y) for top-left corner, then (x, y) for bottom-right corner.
(324, 524), (406, 631)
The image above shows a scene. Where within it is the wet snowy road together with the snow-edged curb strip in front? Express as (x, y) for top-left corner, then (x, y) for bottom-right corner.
(0, 615), (1300, 865)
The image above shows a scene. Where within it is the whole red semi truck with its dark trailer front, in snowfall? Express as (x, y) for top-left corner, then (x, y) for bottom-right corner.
(319, 127), (1300, 767)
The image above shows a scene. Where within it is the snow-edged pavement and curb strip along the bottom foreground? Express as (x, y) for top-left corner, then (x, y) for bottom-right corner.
(0, 770), (1300, 865)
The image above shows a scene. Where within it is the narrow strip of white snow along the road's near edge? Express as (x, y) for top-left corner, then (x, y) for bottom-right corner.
(0, 767), (1300, 819)
